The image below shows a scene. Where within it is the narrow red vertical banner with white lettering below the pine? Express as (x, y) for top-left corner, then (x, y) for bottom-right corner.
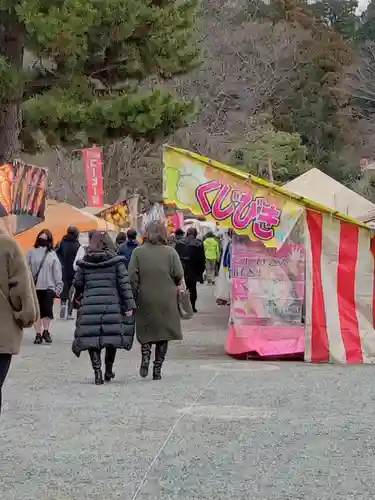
(82, 147), (104, 207)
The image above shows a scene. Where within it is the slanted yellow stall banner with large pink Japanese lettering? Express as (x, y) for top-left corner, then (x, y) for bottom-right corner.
(163, 147), (304, 248)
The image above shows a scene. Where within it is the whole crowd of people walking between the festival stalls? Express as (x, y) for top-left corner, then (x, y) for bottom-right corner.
(0, 221), (226, 412)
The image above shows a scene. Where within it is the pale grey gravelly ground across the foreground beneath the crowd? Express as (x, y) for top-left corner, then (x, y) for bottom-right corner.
(0, 287), (375, 500)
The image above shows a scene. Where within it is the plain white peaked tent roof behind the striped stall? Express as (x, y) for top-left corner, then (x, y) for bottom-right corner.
(284, 168), (375, 218)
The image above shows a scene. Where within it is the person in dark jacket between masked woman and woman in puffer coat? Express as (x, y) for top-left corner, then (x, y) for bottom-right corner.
(56, 226), (81, 319)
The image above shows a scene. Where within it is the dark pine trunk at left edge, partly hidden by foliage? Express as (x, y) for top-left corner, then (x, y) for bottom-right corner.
(0, 9), (24, 165)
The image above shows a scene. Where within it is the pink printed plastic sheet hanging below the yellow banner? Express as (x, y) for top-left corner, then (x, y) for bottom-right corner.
(227, 224), (305, 357)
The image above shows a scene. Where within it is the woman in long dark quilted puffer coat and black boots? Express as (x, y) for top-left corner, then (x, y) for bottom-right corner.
(72, 232), (136, 385)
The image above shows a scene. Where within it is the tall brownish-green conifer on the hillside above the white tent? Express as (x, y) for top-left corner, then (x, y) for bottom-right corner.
(258, 0), (353, 180)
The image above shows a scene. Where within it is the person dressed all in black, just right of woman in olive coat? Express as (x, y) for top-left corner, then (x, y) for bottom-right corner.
(175, 227), (206, 312)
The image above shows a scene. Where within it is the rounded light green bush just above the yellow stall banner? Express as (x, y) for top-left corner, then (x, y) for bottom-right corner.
(233, 124), (311, 184)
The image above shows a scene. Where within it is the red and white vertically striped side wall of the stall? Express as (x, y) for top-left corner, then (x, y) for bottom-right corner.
(305, 209), (375, 363)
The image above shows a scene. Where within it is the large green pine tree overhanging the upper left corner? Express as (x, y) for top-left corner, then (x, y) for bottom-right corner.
(0, 0), (198, 161)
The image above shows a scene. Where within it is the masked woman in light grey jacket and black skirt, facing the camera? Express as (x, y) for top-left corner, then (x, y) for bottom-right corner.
(26, 229), (64, 344)
